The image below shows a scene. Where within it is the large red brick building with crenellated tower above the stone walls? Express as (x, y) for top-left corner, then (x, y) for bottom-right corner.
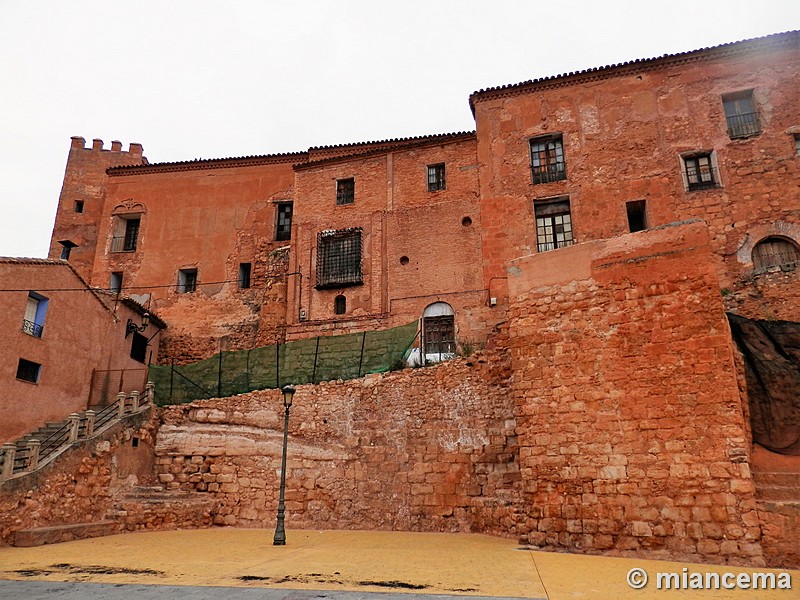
(45, 32), (800, 361)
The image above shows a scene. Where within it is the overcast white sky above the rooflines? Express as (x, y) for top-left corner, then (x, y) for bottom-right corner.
(0, 0), (800, 257)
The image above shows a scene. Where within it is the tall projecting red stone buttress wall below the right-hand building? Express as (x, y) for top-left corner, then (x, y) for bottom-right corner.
(509, 223), (763, 564)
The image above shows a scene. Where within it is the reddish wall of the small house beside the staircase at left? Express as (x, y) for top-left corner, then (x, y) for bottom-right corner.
(0, 259), (158, 442)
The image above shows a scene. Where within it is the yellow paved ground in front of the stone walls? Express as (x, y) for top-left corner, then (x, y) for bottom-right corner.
(0, 528), (800, 600)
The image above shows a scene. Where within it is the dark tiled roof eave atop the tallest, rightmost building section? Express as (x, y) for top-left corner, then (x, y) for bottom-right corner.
(469, 31), (800, 114)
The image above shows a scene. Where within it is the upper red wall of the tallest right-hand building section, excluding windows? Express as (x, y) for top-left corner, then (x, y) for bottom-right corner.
(474, 36), (800, 302)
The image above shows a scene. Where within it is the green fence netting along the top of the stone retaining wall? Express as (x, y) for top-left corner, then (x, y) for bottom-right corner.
(150, 321), (417, 405)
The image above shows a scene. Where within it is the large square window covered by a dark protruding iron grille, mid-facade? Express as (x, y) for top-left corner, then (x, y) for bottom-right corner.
(317, 227), (363, 289)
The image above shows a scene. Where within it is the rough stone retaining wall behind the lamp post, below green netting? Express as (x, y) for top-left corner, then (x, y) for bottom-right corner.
(156, 355), (521, 536)
